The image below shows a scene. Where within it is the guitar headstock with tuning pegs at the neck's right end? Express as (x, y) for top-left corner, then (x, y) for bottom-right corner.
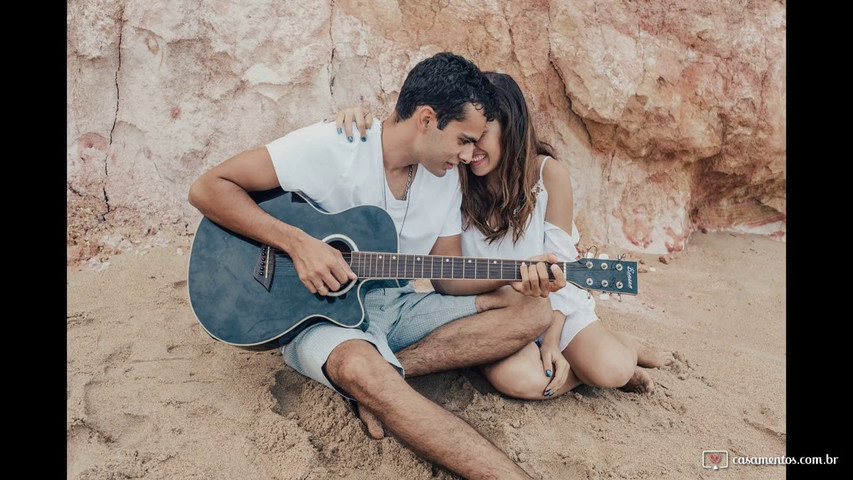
(566, 254), (638, 295)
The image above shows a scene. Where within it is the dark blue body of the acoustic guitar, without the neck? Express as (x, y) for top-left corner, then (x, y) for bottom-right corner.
(187, 189), (399, 347)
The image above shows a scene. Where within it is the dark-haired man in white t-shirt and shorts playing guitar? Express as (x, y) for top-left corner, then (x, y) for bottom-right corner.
(189, 52), (565, 478)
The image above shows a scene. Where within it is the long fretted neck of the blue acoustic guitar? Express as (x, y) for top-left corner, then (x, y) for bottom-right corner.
(350, 251), (566, 280)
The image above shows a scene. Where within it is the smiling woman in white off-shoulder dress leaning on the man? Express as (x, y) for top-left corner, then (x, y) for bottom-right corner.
(328, 72), (674, 399)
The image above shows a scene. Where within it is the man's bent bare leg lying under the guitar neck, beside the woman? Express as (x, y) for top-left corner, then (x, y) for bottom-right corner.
(396, 286), (551, 377)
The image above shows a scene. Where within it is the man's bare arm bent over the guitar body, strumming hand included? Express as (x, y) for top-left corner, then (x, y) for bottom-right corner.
(189, 147), (356, 295)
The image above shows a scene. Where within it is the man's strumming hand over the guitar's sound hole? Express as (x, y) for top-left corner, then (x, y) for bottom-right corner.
(287, 232), (358, 296)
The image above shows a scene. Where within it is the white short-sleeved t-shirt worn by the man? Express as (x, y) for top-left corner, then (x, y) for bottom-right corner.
(266, 119), (462, 254)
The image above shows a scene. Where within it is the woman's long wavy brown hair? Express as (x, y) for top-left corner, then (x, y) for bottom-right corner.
(459, 72), (554, 244)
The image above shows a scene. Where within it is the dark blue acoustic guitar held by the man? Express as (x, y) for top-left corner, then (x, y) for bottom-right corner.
(187, 188), (637, 348)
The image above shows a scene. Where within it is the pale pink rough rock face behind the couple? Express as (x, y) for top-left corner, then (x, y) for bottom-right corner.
(66, 0), (786, 262)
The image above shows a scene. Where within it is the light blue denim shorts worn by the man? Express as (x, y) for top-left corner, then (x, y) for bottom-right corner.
(281, 283), (477, 398)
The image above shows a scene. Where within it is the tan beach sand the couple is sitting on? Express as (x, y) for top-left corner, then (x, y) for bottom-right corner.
(66, 232), (786, 479)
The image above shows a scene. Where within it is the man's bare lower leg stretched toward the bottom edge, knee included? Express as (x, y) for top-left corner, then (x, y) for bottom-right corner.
(326, 340), (530, 479)
